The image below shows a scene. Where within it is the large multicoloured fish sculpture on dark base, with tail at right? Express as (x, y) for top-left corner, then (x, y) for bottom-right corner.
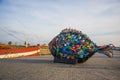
(49, 28), (114, 64)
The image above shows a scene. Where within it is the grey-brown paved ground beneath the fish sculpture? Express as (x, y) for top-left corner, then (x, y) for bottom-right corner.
(0, 51), (120, 80)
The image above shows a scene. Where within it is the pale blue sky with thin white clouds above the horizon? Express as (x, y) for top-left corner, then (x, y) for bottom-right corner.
(0, 0), (120, 46)
